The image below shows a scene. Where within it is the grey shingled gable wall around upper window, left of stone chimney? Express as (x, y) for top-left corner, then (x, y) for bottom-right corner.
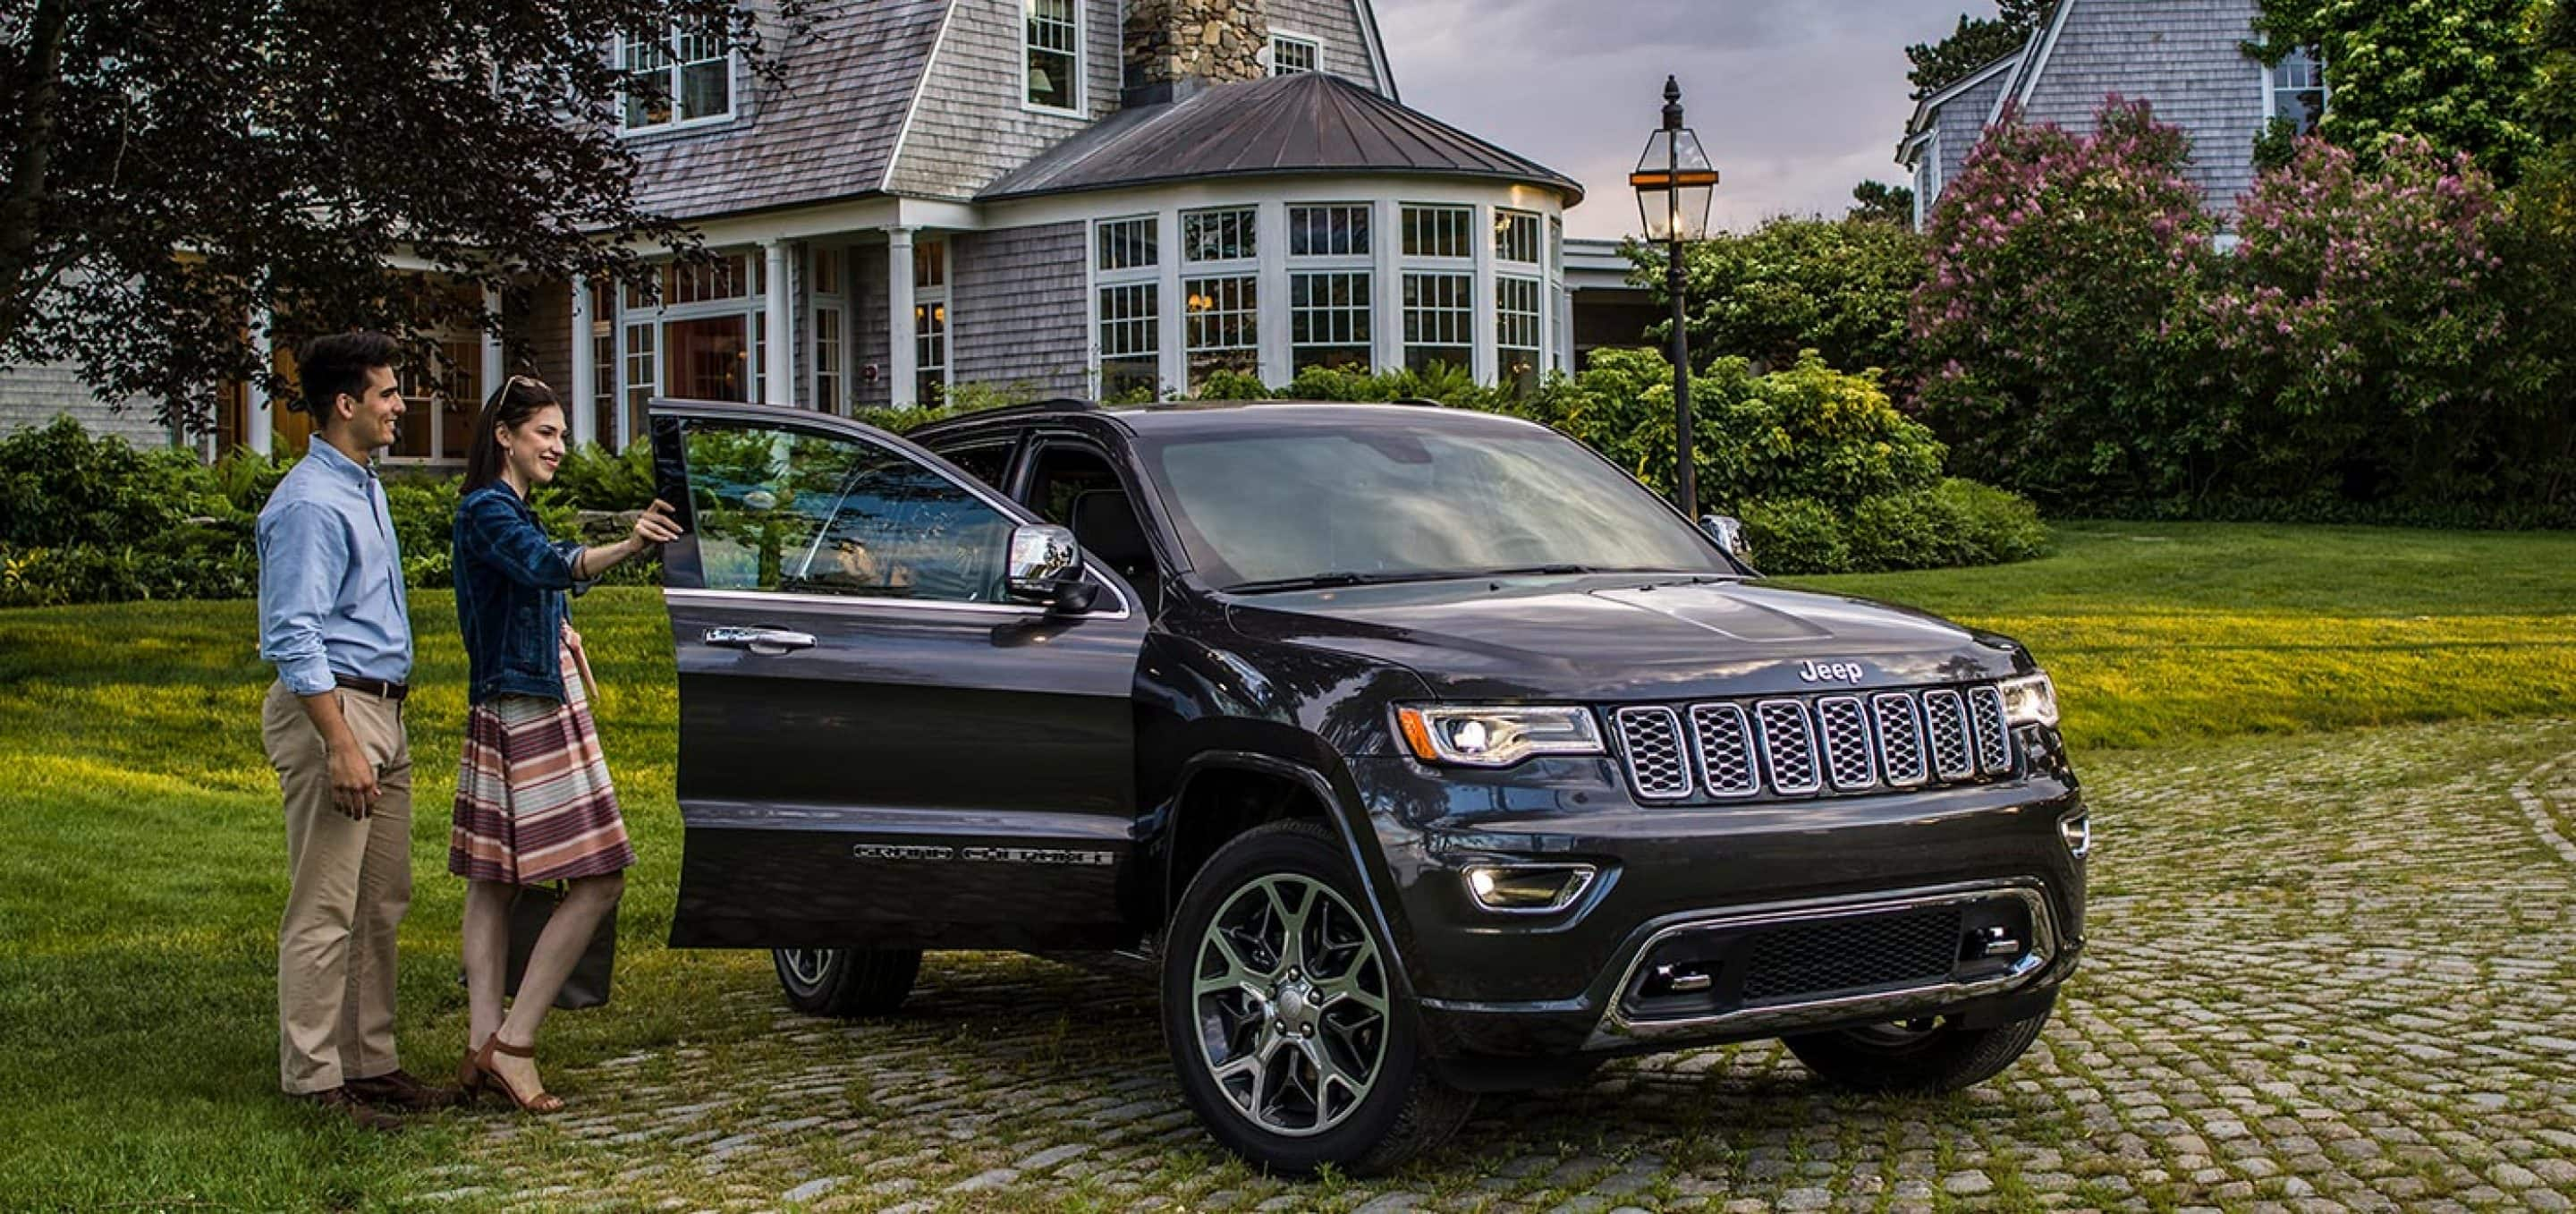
(886, 0), (1126, 201)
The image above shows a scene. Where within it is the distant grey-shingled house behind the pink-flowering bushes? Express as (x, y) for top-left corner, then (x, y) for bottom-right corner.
(1896, 0), (2326, 227)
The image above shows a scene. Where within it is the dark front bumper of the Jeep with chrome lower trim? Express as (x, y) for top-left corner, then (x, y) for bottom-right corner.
(1350, 737), (2084, 1059)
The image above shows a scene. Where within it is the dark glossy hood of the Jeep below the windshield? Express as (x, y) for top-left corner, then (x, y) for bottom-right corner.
(1229, 577), (2032, 701)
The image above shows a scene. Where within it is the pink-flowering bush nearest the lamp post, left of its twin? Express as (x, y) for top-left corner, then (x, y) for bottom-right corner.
(1911, 98), (2236, 503)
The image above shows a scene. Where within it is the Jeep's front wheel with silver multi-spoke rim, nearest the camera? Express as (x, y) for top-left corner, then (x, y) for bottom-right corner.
(1162, 822), (1476, 1176)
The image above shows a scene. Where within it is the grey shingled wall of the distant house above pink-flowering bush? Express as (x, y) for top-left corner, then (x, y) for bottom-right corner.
(2022, 0), (2265, 211)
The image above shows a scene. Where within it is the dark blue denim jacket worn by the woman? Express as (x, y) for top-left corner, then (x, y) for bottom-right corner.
(453, 482), (590, 704)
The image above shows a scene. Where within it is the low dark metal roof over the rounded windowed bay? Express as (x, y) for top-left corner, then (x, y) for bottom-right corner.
(977, 72), (1584, 206)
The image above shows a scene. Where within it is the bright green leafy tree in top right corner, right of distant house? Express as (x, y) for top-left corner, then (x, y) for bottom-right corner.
(2254, 0), (2547, 185)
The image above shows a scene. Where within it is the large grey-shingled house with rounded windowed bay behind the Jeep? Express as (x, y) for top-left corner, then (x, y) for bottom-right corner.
(115, 0), (1581, 464)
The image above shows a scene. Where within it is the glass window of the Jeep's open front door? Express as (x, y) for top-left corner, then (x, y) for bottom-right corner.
(688, 425), (1013, 603)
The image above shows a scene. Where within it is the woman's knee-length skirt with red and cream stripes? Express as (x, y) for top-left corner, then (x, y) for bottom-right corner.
(448, 649), (636, 884)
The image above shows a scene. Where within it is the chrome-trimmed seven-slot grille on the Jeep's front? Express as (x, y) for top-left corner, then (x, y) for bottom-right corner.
(1610, 683), (2012, 802)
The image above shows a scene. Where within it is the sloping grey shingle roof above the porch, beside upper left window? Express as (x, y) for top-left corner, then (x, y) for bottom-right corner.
(626, 0), (953, 219)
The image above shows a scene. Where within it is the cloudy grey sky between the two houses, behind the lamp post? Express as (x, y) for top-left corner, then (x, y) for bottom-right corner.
(1376, 0), (1994, 237)
